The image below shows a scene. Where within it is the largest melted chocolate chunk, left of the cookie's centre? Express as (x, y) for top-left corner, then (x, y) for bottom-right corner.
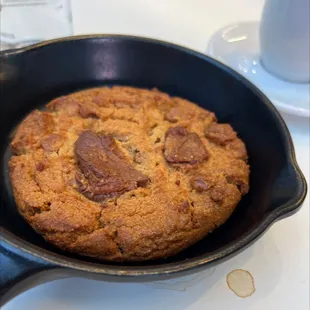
(75, 131), (148, 201)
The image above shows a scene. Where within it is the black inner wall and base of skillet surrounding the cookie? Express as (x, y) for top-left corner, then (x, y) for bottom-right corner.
(0, 36), (305, 270)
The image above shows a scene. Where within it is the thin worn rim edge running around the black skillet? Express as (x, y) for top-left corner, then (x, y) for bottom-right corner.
(0, 34), (307, 277)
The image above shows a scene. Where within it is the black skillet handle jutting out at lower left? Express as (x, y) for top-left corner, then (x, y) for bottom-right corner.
(0, 237), (57, 309)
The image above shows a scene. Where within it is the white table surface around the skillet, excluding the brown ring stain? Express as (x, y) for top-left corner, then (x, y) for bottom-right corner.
(2, 0), (309, 310)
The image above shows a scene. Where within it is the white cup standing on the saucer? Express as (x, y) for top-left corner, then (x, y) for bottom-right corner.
(260, 0), (310, 83)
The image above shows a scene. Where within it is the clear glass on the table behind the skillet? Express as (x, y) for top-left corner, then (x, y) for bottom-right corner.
(0, 0), (73, 50)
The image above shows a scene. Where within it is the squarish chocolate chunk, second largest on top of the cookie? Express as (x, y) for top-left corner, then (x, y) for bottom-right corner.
(164, 126), (208, 164)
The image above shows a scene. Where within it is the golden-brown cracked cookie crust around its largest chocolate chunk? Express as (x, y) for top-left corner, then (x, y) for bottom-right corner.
(9, 86), (249, 261)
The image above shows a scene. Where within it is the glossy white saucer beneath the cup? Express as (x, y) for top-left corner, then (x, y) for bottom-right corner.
(207, 22), (310, 117)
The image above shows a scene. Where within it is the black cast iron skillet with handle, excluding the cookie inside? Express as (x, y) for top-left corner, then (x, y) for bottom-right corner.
(0, 35), (306, 304)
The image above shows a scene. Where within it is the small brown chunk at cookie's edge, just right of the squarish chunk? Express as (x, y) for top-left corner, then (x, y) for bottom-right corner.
(205, 123), (237, 145)
